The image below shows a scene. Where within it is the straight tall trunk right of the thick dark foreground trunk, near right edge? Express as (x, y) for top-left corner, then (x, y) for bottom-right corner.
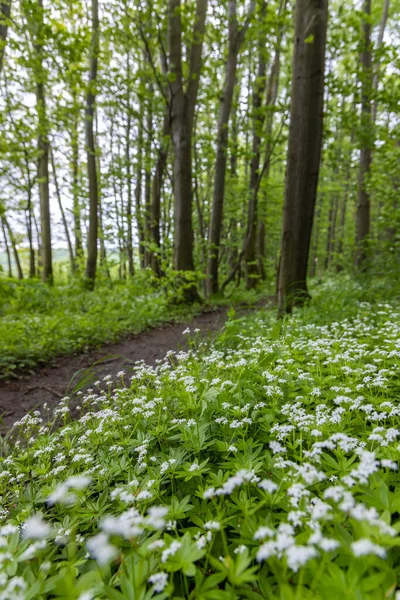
(356, 0), (374, 269)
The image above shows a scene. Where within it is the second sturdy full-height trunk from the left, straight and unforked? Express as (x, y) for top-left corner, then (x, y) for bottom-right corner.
(85, 0), (99, 290)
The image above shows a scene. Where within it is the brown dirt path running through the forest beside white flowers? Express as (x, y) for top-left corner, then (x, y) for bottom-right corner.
(0, 308), (238, 434)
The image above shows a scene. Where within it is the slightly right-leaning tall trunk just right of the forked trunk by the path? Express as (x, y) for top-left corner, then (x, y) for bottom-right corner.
(207, 0), (250, 296)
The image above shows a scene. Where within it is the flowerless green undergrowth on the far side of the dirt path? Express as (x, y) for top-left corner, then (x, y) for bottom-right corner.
(0, 274), (266, 379)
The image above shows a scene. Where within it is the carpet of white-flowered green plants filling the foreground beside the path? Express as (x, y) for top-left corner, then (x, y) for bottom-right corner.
(0, 277), (400, 600)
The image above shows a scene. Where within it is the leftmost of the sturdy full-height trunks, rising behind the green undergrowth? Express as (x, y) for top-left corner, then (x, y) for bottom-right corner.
(34, 0), (53, 284)
